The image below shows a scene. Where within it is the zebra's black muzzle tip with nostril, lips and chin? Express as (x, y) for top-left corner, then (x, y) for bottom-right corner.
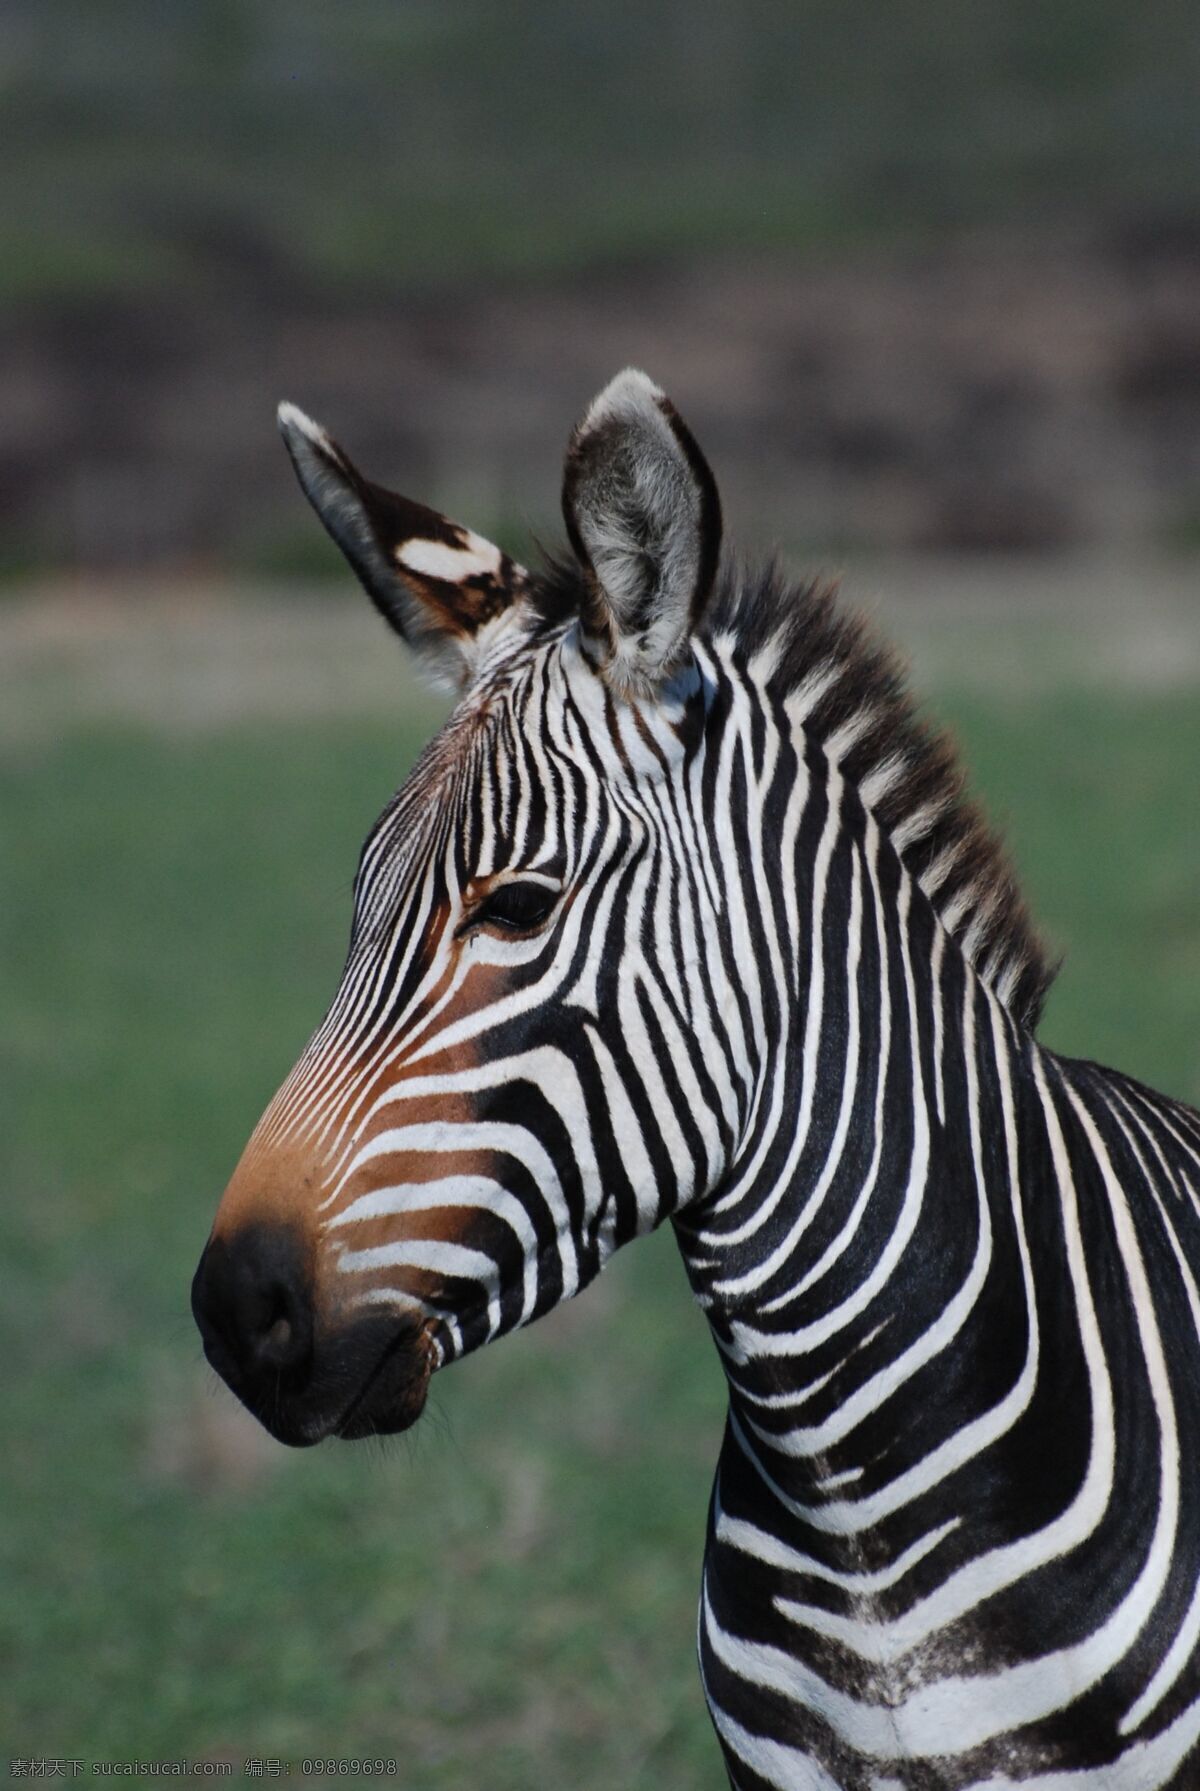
(192, 1225), (442, 1449)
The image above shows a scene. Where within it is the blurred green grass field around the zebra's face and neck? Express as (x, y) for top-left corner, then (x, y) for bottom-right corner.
(0, 690), (1200, 1791)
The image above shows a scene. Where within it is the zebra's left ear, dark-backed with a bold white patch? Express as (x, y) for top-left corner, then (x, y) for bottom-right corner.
(279, 405), (528, 688)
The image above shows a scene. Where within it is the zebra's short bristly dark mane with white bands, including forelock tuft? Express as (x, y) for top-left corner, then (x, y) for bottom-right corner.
(534, 557), (1055, 1030)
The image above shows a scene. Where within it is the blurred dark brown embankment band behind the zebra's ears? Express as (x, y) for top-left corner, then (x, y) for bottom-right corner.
(0, 220), (1200, 575)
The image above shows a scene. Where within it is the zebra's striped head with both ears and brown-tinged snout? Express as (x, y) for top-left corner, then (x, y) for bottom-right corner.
(193, 371), (741, 1444)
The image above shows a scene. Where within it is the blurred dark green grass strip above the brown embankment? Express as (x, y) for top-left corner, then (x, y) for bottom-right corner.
(0, 0), (1200, 303)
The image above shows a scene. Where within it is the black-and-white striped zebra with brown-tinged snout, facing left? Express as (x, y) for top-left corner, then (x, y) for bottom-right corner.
(192, 369), (1200, 1791)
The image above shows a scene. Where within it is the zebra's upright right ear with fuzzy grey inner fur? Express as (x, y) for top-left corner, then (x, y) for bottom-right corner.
(562, 367), (720, 695)
